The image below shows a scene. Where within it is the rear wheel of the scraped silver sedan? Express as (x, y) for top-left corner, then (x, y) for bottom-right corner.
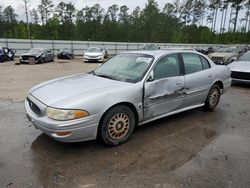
(205, 84), (220, 111)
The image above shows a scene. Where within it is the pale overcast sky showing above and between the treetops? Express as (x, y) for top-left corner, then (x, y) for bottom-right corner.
(0, 0), (244, 29)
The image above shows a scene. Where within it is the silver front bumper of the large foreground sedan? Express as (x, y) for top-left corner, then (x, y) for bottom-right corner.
(25, 95), (100, 142)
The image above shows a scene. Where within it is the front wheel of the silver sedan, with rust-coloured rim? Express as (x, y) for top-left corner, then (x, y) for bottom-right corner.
(98, 105), (135, 146)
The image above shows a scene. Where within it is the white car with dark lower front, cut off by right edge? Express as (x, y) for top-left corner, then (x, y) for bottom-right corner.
(229, 51), (250, 83)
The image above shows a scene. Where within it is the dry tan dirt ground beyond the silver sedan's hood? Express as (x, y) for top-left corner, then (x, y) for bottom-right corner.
(0, 58), (98, 101)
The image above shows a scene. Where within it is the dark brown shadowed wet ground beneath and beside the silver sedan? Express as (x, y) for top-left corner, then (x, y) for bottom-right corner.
(31, 109), (216, 187)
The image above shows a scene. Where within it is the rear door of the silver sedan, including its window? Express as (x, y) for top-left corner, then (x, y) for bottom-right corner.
(181, 53), (214, 107)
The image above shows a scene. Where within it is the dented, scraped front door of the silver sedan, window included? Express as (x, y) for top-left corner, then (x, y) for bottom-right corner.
(144, 54), (184, 120)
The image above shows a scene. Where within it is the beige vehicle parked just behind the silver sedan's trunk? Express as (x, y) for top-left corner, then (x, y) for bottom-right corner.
(208, 45), (248, 65)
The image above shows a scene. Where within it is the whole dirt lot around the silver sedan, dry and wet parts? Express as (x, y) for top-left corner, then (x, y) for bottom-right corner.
(0, 60), (250, 188)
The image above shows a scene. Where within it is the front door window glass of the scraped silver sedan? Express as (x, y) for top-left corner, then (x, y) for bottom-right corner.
(154, 54), (180, 80)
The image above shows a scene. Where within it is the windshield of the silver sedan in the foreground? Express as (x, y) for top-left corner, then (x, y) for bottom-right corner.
(92, 54), (154, 83)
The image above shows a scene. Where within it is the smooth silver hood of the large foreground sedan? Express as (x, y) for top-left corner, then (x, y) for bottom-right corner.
(30, 74), (132, 108)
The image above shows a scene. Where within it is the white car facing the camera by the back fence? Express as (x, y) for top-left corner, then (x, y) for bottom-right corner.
(84, 47), (105, 63)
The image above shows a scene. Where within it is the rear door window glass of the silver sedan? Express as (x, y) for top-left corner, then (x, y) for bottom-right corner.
(182, 53), (203, 74)
